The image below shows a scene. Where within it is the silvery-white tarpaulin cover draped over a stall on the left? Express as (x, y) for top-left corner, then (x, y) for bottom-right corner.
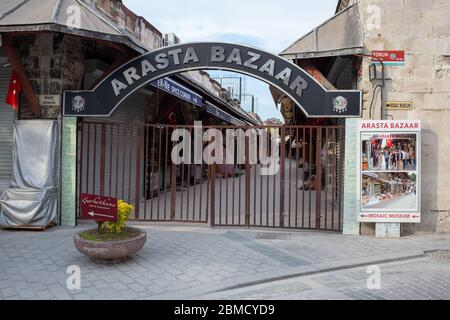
(0, 120), (59, 227)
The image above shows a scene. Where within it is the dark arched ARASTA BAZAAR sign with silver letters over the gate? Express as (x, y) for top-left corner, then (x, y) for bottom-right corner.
(63, 43), (362, 118)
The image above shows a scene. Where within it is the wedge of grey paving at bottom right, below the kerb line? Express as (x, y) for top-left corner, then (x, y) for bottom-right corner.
(199, 257), (450, 300)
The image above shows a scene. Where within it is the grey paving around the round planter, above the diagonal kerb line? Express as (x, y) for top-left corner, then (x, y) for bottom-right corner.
(0, 226), (450, 299)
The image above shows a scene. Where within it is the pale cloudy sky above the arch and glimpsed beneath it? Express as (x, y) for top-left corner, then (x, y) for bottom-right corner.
(123, 0), (337, 119)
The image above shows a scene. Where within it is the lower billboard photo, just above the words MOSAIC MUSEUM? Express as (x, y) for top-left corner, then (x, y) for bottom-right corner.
(361, 172), (419, 212)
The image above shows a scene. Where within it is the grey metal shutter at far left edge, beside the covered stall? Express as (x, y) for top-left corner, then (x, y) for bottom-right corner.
(0, 67), (16, 194)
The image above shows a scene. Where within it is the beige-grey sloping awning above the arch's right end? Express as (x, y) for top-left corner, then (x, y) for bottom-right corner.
(280, 3), (364, 59)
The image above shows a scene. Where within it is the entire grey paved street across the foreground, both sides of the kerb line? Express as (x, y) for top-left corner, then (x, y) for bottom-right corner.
(0, 227), (450, 299)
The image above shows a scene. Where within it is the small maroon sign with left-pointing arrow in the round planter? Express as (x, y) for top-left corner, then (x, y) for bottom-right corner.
(80, 193), (117, 222)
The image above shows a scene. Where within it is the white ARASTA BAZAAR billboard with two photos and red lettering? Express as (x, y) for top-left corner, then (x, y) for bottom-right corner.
(357, 120), (421, 223)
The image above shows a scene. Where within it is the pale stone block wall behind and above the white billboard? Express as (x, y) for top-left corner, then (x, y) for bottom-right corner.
(358, 0), (450, 232)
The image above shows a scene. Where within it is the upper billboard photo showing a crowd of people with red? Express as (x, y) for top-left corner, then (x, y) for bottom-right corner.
(361, 133), (418, 172)
